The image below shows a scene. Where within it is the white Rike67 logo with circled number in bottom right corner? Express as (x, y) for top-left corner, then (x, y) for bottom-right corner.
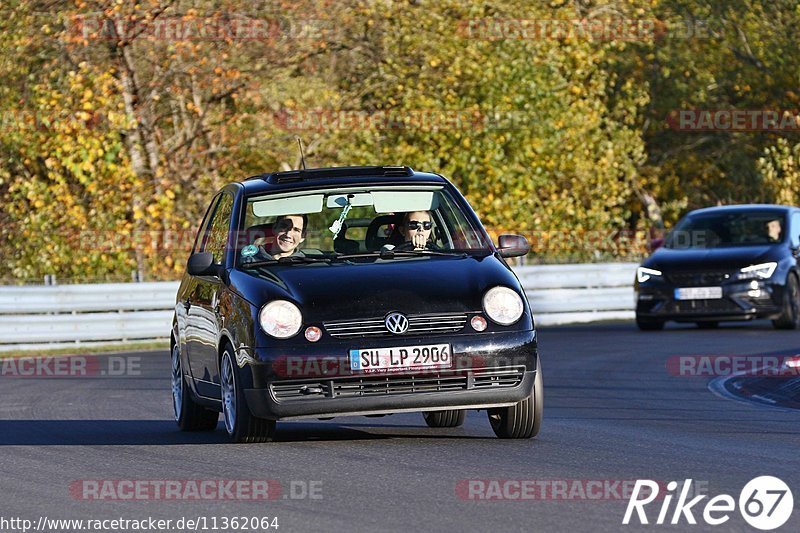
(622, 476), (794, 531)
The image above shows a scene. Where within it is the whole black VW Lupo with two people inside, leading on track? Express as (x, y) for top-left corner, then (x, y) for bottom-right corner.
(172, 167), (543, 442)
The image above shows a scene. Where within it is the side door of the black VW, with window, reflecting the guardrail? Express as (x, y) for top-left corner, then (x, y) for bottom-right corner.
(187, 192), (233, 398)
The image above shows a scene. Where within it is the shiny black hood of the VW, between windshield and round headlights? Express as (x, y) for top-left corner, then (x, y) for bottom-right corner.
(231, 255), (522, 323)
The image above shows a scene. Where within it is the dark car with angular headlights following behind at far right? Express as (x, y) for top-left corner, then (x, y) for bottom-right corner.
(635, 205), (800, 330)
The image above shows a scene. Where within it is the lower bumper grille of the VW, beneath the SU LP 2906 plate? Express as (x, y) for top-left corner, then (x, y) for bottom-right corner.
(270, 366), (525, 402)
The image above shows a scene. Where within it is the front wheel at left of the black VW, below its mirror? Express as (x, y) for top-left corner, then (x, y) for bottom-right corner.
(220, 344), (275, 443)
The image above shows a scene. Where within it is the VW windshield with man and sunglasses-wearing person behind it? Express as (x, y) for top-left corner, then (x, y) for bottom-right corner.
(237, 186), (490, 266)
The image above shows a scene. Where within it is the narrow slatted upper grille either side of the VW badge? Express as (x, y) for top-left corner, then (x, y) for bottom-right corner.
(322, 313), (467, 339)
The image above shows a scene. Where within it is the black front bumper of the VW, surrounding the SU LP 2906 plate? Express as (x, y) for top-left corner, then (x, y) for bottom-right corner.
(238, 331), (539, 420)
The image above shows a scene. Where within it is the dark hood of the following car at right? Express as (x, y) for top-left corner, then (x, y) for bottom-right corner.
(642, 245), (781, 271)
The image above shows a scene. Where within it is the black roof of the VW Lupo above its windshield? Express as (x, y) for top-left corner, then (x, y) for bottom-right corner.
(241, 166), (449, 195)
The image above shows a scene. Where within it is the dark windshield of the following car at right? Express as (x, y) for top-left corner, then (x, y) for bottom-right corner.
(665, 211), (786, 250)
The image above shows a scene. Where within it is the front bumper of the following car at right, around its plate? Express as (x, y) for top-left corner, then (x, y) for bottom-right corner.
(636, 281), (784, 322)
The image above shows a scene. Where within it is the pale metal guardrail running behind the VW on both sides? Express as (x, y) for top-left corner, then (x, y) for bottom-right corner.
(0, 263), (637, 351)
